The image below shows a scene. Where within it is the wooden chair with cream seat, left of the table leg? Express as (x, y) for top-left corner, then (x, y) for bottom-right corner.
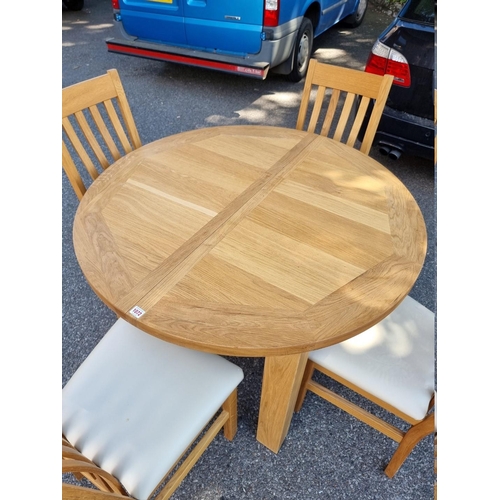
(62, 319), (243, 500)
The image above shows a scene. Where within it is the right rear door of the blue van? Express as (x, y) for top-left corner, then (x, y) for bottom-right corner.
(183, 0), (264, 55)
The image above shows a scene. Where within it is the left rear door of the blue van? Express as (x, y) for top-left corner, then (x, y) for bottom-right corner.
(120, 0), (188, 46)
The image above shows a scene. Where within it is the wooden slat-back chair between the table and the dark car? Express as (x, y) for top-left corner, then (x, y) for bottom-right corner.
(295, 59), (394, 154)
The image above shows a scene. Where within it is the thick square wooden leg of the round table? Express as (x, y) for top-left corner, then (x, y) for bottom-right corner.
(257, 352), (308, 453)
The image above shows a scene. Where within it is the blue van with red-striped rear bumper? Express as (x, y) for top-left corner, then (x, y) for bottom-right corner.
(106, 0), (367, 82)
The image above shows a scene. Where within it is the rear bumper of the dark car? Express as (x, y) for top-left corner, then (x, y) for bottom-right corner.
(374, 106), (435, 160)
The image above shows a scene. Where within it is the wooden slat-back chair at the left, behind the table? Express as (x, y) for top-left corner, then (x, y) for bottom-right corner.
(62, 69), (141, 200)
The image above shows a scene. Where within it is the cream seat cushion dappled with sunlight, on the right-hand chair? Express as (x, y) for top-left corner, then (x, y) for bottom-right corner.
(309, 296), (434, 420)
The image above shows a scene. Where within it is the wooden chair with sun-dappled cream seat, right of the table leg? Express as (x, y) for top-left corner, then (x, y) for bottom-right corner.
(295, 296), (435, 478)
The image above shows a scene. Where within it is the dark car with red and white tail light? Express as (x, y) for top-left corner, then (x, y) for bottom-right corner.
(365, 0), (437, 160)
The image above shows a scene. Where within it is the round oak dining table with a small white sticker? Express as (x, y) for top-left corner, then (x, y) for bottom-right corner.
(73, 126), (427, 453)
